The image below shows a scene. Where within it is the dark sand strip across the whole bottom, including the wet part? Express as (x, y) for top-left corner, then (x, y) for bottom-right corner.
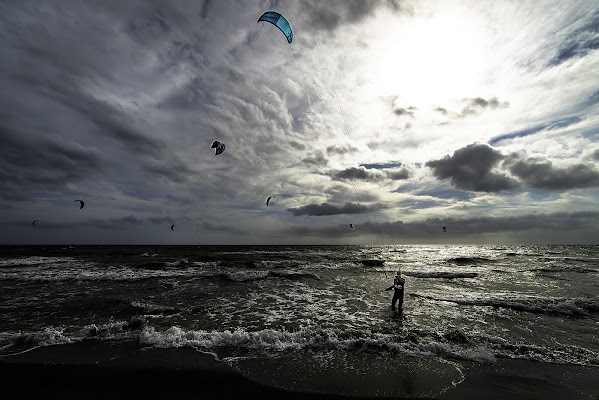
(0, 342), (599, 400)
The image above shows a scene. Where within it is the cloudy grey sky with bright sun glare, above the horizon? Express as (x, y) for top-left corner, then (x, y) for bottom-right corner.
(0, 0), (599, 245)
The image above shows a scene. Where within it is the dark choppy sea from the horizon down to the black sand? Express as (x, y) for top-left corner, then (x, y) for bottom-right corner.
(0, 245), (599, 399)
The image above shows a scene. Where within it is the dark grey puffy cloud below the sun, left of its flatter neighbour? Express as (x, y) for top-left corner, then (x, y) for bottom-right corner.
(426, 144), (518, 192)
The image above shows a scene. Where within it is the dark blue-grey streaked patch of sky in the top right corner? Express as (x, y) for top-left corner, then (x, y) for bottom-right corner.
(548, 12), (599, 67)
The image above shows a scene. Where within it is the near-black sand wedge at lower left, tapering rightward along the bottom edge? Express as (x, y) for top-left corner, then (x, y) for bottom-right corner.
(0, 342), (432, 400)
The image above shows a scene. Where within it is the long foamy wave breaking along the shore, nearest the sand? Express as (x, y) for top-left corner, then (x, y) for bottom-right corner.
(0, 317), (599, 366)
